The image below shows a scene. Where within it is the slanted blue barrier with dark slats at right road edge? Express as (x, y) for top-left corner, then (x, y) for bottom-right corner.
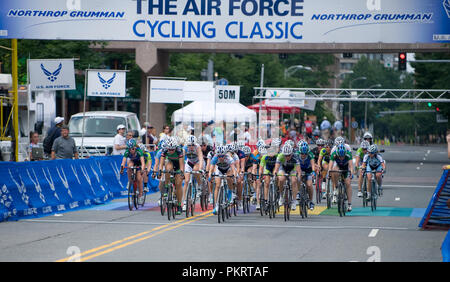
(419, 169), (450, 230)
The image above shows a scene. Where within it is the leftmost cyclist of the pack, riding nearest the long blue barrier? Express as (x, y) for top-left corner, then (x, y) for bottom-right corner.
(120, 139), (147, 205)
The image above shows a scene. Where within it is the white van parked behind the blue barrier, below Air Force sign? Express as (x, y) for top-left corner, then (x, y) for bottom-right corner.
(69, 111), (141, 158)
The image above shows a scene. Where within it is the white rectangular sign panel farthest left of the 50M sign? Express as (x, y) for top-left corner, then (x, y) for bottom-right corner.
(150, 79), (185, 104)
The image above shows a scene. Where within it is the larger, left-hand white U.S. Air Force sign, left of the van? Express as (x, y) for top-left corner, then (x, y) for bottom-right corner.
(28, 59), (76, 91)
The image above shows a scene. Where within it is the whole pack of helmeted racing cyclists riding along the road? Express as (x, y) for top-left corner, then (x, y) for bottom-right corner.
(121, 128), (386, 214)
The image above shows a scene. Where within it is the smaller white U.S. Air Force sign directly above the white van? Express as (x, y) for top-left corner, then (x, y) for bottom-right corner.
(87, 70), (126, 97)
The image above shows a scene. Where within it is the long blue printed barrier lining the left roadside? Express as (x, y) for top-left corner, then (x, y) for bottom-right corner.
(0, 156), (158, 222)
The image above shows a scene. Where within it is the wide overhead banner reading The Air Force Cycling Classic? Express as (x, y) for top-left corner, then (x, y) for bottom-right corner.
(0, 0), (450, 43)
